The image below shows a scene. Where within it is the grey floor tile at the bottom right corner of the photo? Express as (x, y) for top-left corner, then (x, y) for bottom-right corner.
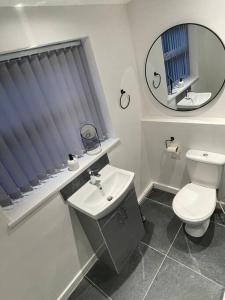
(145, 258), (223, 300)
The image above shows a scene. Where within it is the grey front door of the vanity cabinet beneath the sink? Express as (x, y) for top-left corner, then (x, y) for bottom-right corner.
(99, 188), (144, 272)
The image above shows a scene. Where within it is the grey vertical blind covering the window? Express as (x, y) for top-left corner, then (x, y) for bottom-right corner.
(0, 45), (107, 206)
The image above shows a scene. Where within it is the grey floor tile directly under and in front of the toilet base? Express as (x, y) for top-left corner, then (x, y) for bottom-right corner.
(168, 222), (225, 285)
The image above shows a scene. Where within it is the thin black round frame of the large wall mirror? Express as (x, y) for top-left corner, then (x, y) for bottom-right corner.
(145, 23), (225, 113)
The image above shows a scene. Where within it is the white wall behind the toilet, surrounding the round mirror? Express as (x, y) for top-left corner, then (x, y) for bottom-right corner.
(128, 0), (225, 193)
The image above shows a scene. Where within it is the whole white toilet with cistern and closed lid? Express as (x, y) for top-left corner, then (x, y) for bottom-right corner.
(173, 150), (225, 237)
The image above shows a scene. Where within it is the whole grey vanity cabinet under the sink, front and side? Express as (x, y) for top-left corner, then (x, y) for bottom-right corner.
(77, 186), (145, 273)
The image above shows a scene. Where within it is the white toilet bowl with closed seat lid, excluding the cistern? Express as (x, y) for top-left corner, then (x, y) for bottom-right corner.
(172, 183), (216, 237)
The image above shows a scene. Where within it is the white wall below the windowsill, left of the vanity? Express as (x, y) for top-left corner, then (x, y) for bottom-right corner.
(0, 195), (93, 300)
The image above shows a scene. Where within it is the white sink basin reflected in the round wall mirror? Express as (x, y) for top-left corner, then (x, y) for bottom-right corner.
(177, 92), (212, 109)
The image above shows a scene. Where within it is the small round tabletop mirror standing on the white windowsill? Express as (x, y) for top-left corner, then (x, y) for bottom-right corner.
(80, 123), (102, 155)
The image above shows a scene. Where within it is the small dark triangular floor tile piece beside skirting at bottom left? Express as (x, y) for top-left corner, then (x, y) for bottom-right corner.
(68, 278), (108, 300)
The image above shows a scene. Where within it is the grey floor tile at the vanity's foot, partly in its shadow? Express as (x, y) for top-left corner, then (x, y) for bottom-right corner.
(87, 244), (164, 300)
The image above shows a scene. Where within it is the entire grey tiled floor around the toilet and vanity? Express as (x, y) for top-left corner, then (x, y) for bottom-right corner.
(69, 190), (225, 300)
